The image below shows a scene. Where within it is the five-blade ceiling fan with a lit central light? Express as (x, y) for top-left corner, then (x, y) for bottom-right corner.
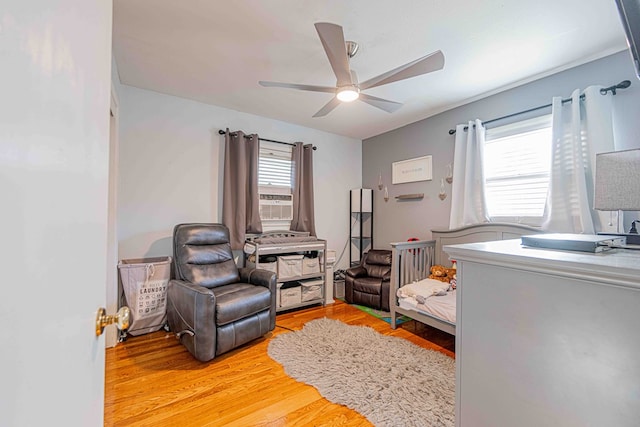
(258, 22), (444, 117)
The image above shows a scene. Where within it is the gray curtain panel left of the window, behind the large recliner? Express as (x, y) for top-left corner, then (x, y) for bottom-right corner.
(222, 129), (262, 250)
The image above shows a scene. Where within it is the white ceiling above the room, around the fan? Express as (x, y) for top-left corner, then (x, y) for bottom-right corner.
(113, 0), (626, 139)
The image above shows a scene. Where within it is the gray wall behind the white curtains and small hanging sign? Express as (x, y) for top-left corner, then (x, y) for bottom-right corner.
(362, 51), (640, 248)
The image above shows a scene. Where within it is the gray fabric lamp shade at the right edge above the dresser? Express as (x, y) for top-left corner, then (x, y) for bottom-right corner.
(594, 149), (640, 211)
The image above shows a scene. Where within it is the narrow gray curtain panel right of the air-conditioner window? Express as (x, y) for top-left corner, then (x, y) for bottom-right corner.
(291, 142), (316, 236)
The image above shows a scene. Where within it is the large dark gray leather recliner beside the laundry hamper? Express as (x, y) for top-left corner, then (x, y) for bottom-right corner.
(167, 224), (276, 362)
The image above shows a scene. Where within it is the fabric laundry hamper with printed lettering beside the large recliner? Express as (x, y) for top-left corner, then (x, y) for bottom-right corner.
(118, 257), (171, 336)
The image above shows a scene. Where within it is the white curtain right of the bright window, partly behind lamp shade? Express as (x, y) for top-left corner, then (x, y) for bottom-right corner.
(542, 86), (617, 234)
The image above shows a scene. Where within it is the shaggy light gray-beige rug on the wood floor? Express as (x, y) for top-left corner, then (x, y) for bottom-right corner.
(268, 318), (455, 427)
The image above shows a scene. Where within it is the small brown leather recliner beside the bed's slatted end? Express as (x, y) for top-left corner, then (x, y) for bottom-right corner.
(344, 249), (391, 311)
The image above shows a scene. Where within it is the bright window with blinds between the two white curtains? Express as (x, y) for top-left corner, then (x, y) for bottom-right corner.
(484, 115), (552, 226)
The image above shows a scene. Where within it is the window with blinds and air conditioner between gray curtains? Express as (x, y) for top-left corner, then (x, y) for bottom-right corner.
(258, 141), (293, 231)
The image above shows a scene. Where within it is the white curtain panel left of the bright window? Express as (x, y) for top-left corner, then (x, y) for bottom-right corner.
(449, 119), (489, 229)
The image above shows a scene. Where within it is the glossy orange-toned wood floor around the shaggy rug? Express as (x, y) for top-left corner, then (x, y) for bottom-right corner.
(105, 301), (455, 427)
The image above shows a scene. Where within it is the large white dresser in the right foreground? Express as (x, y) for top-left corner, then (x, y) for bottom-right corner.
(444, 239), (640, 427)
